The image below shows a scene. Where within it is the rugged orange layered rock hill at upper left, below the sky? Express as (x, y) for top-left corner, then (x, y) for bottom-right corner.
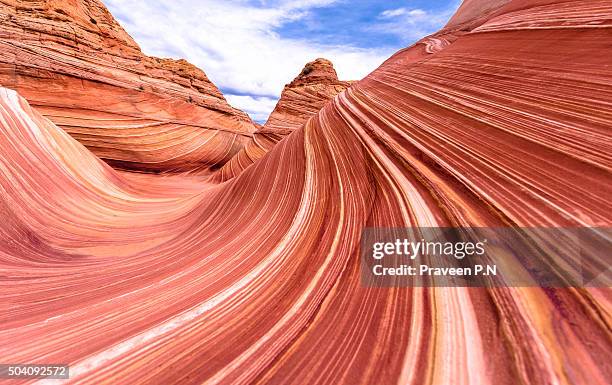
(0, 0), (255, 172)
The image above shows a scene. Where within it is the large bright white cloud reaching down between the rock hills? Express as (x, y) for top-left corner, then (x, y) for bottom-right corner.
(104, 0), (393, 121)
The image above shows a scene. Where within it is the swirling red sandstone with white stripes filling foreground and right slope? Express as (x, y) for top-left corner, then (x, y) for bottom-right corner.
(0, 0), (612, 385)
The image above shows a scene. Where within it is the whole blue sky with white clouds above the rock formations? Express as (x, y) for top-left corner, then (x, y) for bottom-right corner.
(103, 0), (460, 122)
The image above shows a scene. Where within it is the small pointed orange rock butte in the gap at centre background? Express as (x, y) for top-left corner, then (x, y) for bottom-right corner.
(213, 58), (353, 181)
